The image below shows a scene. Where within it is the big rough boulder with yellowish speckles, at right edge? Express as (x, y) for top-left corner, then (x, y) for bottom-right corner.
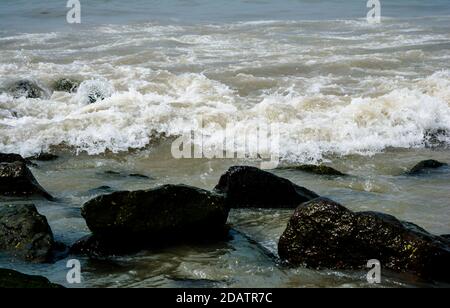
(278, 198), (450, 281)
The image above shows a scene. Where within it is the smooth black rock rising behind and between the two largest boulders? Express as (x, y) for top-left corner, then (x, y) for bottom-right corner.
(215, 166), (319, 208)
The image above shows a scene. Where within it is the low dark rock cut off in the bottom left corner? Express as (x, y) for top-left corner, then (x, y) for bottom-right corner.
(0, 268), (64, 289)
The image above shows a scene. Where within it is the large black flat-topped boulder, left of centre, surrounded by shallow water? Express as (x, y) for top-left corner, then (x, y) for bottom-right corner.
(76, 185), (229, 253)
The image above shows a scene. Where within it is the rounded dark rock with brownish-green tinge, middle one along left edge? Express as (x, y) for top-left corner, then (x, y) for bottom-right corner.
(0, 204), (55, 262)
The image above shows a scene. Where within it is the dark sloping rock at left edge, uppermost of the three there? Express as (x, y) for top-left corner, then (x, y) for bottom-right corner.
(0, 161), (53, 200)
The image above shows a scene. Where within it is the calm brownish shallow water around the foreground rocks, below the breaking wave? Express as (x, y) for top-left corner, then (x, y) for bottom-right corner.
(0, 144), (450, 287)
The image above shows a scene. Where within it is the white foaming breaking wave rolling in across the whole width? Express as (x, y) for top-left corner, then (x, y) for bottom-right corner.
(0, 71), (450, 161)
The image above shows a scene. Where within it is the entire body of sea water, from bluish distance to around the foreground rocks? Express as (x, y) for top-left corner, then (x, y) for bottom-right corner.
(0, 0), (450, 287)
